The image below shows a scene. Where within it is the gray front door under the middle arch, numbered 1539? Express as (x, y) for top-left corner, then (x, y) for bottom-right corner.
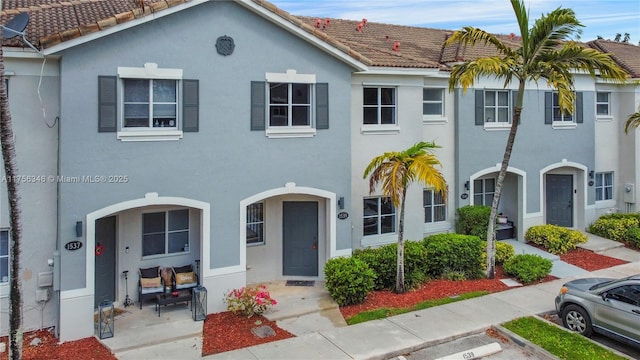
(282, 201), (318, 276)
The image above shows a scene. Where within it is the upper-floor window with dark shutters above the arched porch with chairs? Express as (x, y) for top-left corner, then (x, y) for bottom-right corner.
(122, 79), (178, 129)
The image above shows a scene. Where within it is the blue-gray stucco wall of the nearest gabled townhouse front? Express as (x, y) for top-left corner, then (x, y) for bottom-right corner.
(55, 2), (352, 289)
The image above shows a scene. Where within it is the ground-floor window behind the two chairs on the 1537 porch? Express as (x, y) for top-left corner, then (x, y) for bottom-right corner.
(142, 209), (189, 257)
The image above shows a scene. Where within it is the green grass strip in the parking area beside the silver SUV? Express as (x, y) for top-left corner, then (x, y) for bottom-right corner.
(502, 317), (626, 359)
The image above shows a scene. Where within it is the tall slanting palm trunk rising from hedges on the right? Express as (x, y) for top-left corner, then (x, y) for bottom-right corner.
(486, 81), (524, 279)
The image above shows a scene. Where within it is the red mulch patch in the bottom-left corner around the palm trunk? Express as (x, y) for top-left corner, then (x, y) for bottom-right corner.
(0, 330), (117, 360)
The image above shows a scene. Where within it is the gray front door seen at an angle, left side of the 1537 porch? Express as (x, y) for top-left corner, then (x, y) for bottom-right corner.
(94, 216), (116, 307)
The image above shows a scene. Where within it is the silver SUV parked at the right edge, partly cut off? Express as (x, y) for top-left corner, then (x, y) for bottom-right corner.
(556, 274), (640, 347)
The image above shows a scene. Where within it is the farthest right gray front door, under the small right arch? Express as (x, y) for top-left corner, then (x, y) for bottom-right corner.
(547, 174), (573, 227)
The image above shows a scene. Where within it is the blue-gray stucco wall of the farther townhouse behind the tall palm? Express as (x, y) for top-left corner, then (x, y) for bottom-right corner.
(456, 90), (595, 213)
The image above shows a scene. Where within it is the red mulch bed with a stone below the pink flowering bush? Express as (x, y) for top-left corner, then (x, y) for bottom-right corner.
(202, 311), (294, 356)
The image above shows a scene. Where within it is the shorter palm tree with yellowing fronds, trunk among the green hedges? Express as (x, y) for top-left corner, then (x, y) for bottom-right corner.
(363, 141), (447, 293)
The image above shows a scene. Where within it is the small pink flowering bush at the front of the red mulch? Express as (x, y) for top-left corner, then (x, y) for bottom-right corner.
(224, 285), (277, 317)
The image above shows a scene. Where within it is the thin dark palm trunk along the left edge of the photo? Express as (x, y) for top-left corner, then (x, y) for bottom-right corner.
(0, 47), (23, 360)
